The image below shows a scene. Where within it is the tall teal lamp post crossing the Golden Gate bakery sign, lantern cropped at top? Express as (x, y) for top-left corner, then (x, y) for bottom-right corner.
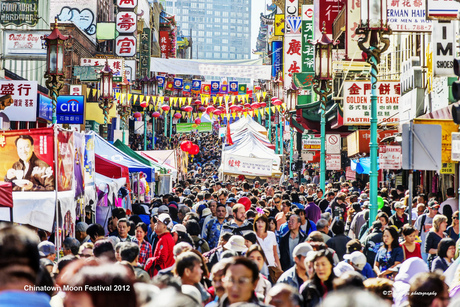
(356, 0), (391, 224)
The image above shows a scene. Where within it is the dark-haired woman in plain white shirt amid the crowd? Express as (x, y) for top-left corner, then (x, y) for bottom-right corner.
(254, 214), (281, 269)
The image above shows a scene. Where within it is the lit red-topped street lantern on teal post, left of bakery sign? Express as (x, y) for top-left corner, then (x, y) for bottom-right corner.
(312, 23), (337, 196)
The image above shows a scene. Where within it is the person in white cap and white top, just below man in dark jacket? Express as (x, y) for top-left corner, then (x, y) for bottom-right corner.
(277, 242), (313, 289)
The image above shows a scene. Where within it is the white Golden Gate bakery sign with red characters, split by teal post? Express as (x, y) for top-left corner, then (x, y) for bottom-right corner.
(343, 81), (401, 126)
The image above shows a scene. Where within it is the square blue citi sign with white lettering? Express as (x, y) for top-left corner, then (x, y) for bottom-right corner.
(56, 95), (85, 124)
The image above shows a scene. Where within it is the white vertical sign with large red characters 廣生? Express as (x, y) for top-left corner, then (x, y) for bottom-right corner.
(284, 35), (302, 89)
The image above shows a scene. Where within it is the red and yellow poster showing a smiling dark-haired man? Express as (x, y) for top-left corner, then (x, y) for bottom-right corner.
(0, 128), (55, 192)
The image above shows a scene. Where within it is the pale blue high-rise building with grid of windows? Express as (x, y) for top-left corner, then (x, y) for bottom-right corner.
(163, 0), (251, 60)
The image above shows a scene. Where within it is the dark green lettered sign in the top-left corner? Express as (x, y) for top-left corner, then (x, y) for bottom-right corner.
(0, 0), (38, 27)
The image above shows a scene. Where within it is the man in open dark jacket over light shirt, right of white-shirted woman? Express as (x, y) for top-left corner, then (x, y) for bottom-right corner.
(279, 214), (306, 271)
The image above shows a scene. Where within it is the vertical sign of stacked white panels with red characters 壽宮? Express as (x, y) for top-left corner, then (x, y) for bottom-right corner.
(115, 0), (137, 57)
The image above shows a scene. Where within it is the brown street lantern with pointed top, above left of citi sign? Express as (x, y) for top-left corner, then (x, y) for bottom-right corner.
(42, 18), (70, 124)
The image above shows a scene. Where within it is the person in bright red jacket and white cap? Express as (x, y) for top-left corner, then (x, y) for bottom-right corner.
(145, 213), (175, 277)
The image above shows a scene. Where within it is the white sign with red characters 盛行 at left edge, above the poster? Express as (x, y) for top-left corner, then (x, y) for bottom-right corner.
(0, 80), (38, 122)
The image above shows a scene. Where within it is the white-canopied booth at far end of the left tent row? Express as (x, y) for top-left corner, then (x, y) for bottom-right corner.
(140, 149), (178, 194)
